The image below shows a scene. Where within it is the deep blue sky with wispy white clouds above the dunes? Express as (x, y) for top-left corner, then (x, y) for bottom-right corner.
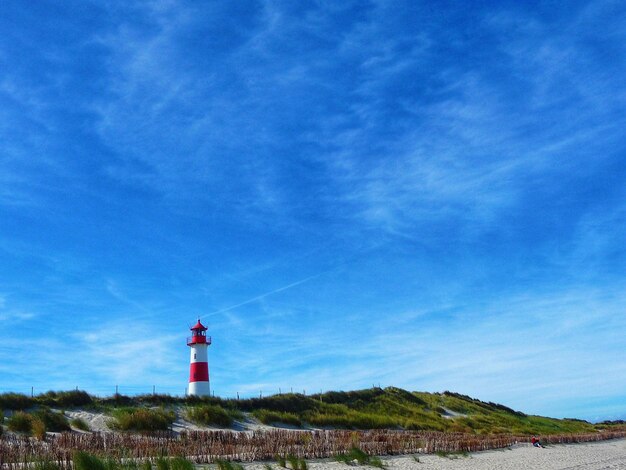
(0, 0), (626, 419)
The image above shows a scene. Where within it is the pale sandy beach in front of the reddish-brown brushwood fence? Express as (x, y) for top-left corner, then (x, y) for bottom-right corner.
(239, 439), (626, 470)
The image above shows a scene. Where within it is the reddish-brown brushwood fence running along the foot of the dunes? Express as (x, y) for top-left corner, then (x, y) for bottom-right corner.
(0, 430), (626, 470)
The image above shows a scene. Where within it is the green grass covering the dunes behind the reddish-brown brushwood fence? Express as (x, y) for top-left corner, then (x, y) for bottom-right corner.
(0, 387), (604, 435)
